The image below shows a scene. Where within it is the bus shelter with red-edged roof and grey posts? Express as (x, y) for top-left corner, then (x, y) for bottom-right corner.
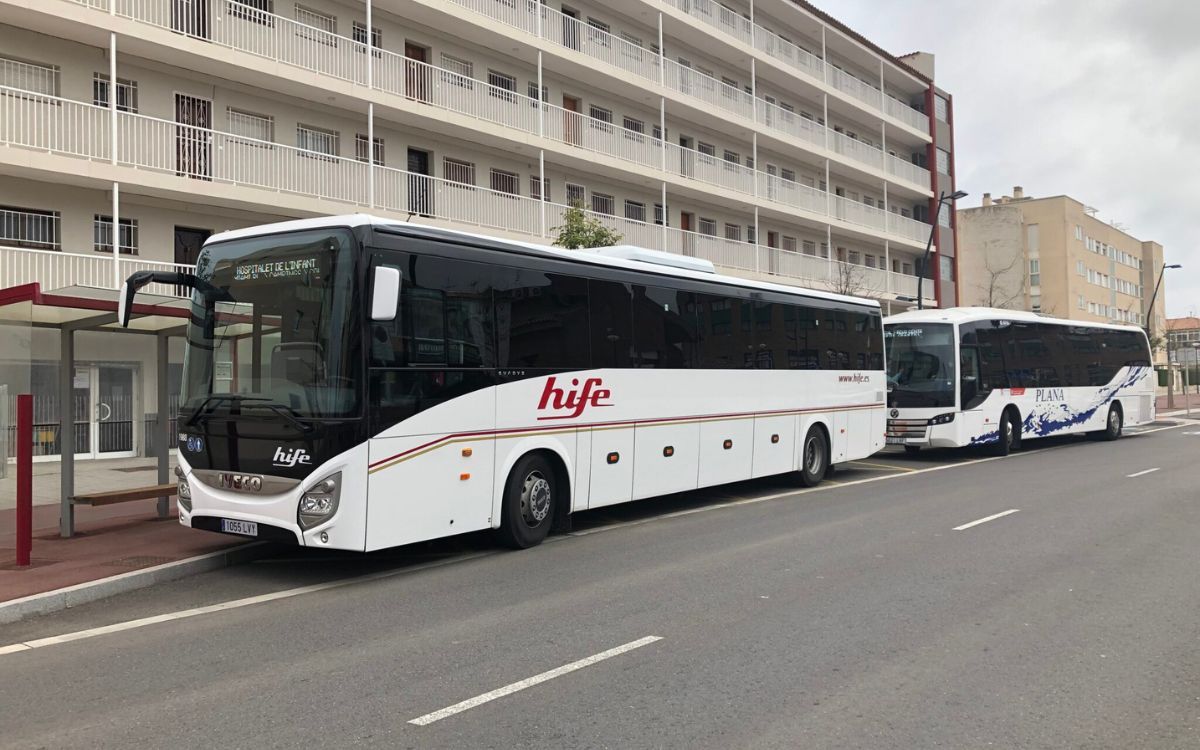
(0, 283), (190, 538)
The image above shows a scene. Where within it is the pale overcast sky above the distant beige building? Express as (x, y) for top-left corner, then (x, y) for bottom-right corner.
(814, 0), (1200, 317)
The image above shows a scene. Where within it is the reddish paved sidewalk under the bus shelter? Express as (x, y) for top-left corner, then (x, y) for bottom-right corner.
(0, 494), (248, 602)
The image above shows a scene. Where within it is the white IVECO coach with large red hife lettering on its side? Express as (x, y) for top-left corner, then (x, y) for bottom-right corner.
(121, 216), (886, 551)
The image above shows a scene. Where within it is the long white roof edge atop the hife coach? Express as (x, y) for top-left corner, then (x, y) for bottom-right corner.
(205, 214), (880, 308)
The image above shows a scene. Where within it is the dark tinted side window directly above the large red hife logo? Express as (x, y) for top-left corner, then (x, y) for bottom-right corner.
(496, 268), (590, 370)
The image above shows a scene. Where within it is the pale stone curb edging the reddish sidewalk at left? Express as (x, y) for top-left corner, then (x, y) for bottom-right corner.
(0, 541), (270, 624)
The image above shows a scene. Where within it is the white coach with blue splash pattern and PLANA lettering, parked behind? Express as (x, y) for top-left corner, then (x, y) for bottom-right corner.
(883, 307), (1154, 455)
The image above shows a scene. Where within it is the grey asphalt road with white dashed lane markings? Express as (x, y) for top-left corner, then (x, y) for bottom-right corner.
(0, 425), (1200, 749)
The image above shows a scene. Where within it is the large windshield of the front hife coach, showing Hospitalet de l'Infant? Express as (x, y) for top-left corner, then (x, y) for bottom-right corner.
(180, 229), (362, 422)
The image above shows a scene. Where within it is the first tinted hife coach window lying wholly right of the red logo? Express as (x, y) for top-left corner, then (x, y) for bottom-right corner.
(634, 284), (700, 368)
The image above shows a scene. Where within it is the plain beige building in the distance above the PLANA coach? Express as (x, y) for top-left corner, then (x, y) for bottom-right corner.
(959, 187), (1170, 334)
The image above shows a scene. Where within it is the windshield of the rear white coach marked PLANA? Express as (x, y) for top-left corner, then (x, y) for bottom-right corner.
(883, 323), (955, 408)
